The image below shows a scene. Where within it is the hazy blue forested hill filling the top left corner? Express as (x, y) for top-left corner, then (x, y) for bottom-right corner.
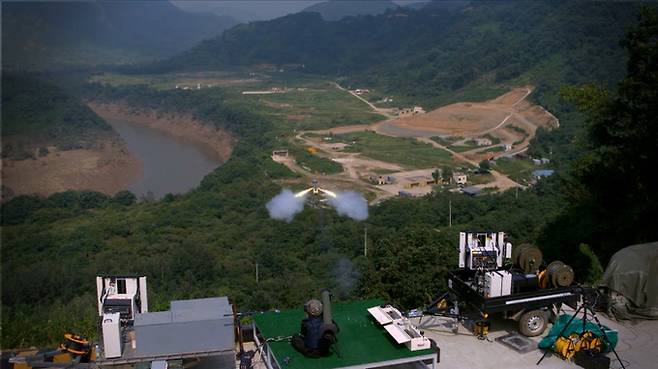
(2, 1), (237, 69)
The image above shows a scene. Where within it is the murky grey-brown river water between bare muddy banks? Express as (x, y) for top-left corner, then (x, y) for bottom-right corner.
(108, 120), (221, 198)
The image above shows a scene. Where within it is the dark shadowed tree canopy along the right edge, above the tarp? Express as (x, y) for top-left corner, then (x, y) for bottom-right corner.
(545, 7), (658, 268)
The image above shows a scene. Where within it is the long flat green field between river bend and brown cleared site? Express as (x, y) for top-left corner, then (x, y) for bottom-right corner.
(90, 69), (385, 131)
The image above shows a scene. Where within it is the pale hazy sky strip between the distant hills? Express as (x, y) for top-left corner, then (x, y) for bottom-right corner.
(172, 0), (422, 22)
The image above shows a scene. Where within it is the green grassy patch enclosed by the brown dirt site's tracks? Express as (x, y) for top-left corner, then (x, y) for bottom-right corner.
(334, 132), (455, 169)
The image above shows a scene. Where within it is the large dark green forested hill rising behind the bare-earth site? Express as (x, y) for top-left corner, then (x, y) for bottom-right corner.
(156, 1), (640, 106)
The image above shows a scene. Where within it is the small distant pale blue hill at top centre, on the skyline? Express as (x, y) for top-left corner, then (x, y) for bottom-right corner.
(302, 0), (398, 21)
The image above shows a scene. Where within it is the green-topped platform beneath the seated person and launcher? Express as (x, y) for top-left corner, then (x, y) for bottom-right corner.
(254, 300), (436, 369)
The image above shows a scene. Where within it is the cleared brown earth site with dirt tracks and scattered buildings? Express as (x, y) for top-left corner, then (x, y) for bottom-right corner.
(272, 86), (559, 200)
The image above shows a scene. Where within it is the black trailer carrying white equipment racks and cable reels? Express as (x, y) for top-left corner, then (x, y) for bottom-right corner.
(423, 232), (583, 337)
